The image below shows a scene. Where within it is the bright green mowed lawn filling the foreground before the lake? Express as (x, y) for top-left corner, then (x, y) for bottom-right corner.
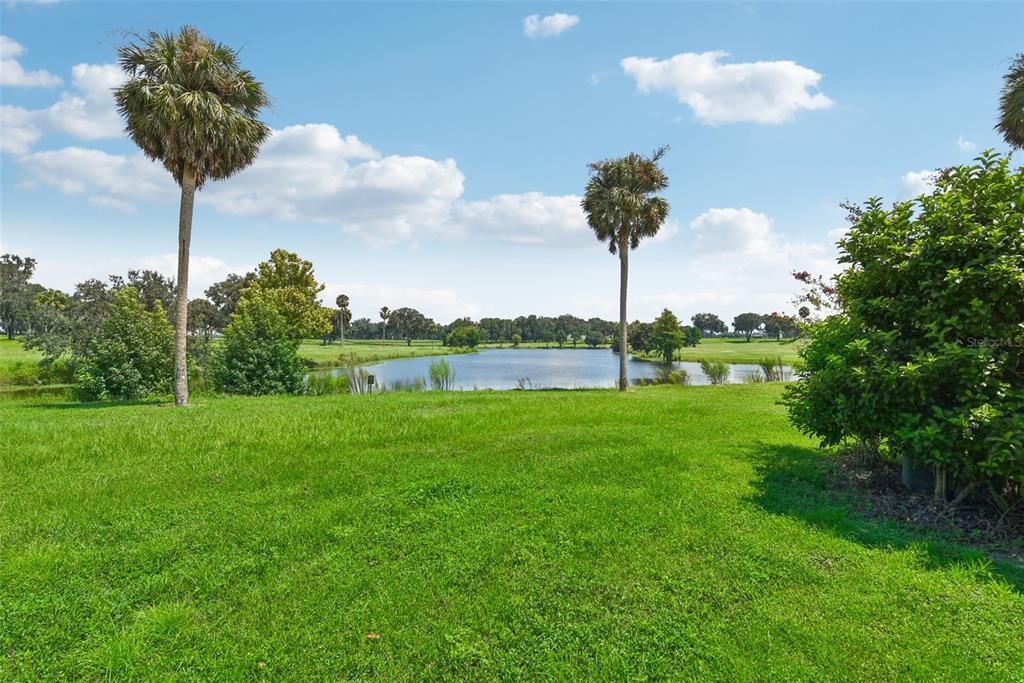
(0, 385), (1024, 681)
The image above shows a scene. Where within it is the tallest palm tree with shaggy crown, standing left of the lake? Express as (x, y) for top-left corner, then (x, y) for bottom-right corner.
(114, 26), (270, 405)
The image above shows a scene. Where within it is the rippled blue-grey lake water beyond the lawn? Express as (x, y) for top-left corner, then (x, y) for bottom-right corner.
(311, 348), (790, 390)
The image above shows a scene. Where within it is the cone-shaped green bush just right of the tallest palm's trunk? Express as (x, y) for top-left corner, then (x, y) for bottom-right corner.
(211, 288), (304, 395)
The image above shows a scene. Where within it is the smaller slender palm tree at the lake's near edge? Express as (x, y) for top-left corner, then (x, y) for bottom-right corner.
(582, 146), (669, 391)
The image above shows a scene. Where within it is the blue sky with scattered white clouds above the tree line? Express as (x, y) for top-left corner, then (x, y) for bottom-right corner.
(0, 1), (1024, 322)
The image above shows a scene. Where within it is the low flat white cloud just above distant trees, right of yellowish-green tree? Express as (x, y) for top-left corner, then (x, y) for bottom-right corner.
(321, 283), (480, 325)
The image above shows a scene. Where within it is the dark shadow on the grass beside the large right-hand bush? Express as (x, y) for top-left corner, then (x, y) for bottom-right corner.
(751, 444), (1024, 593)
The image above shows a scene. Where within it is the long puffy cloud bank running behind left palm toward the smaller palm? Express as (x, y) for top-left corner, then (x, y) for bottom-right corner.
(12, 124), (592, 246)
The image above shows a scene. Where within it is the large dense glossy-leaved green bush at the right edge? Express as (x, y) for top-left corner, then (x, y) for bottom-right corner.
(786, 153), (1024, 489)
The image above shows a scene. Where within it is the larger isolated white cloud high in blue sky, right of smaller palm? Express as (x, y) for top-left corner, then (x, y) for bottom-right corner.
(621, 51), (833, 125)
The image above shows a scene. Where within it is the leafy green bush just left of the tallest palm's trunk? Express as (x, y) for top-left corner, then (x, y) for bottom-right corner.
(75, 287), (174, 400)
